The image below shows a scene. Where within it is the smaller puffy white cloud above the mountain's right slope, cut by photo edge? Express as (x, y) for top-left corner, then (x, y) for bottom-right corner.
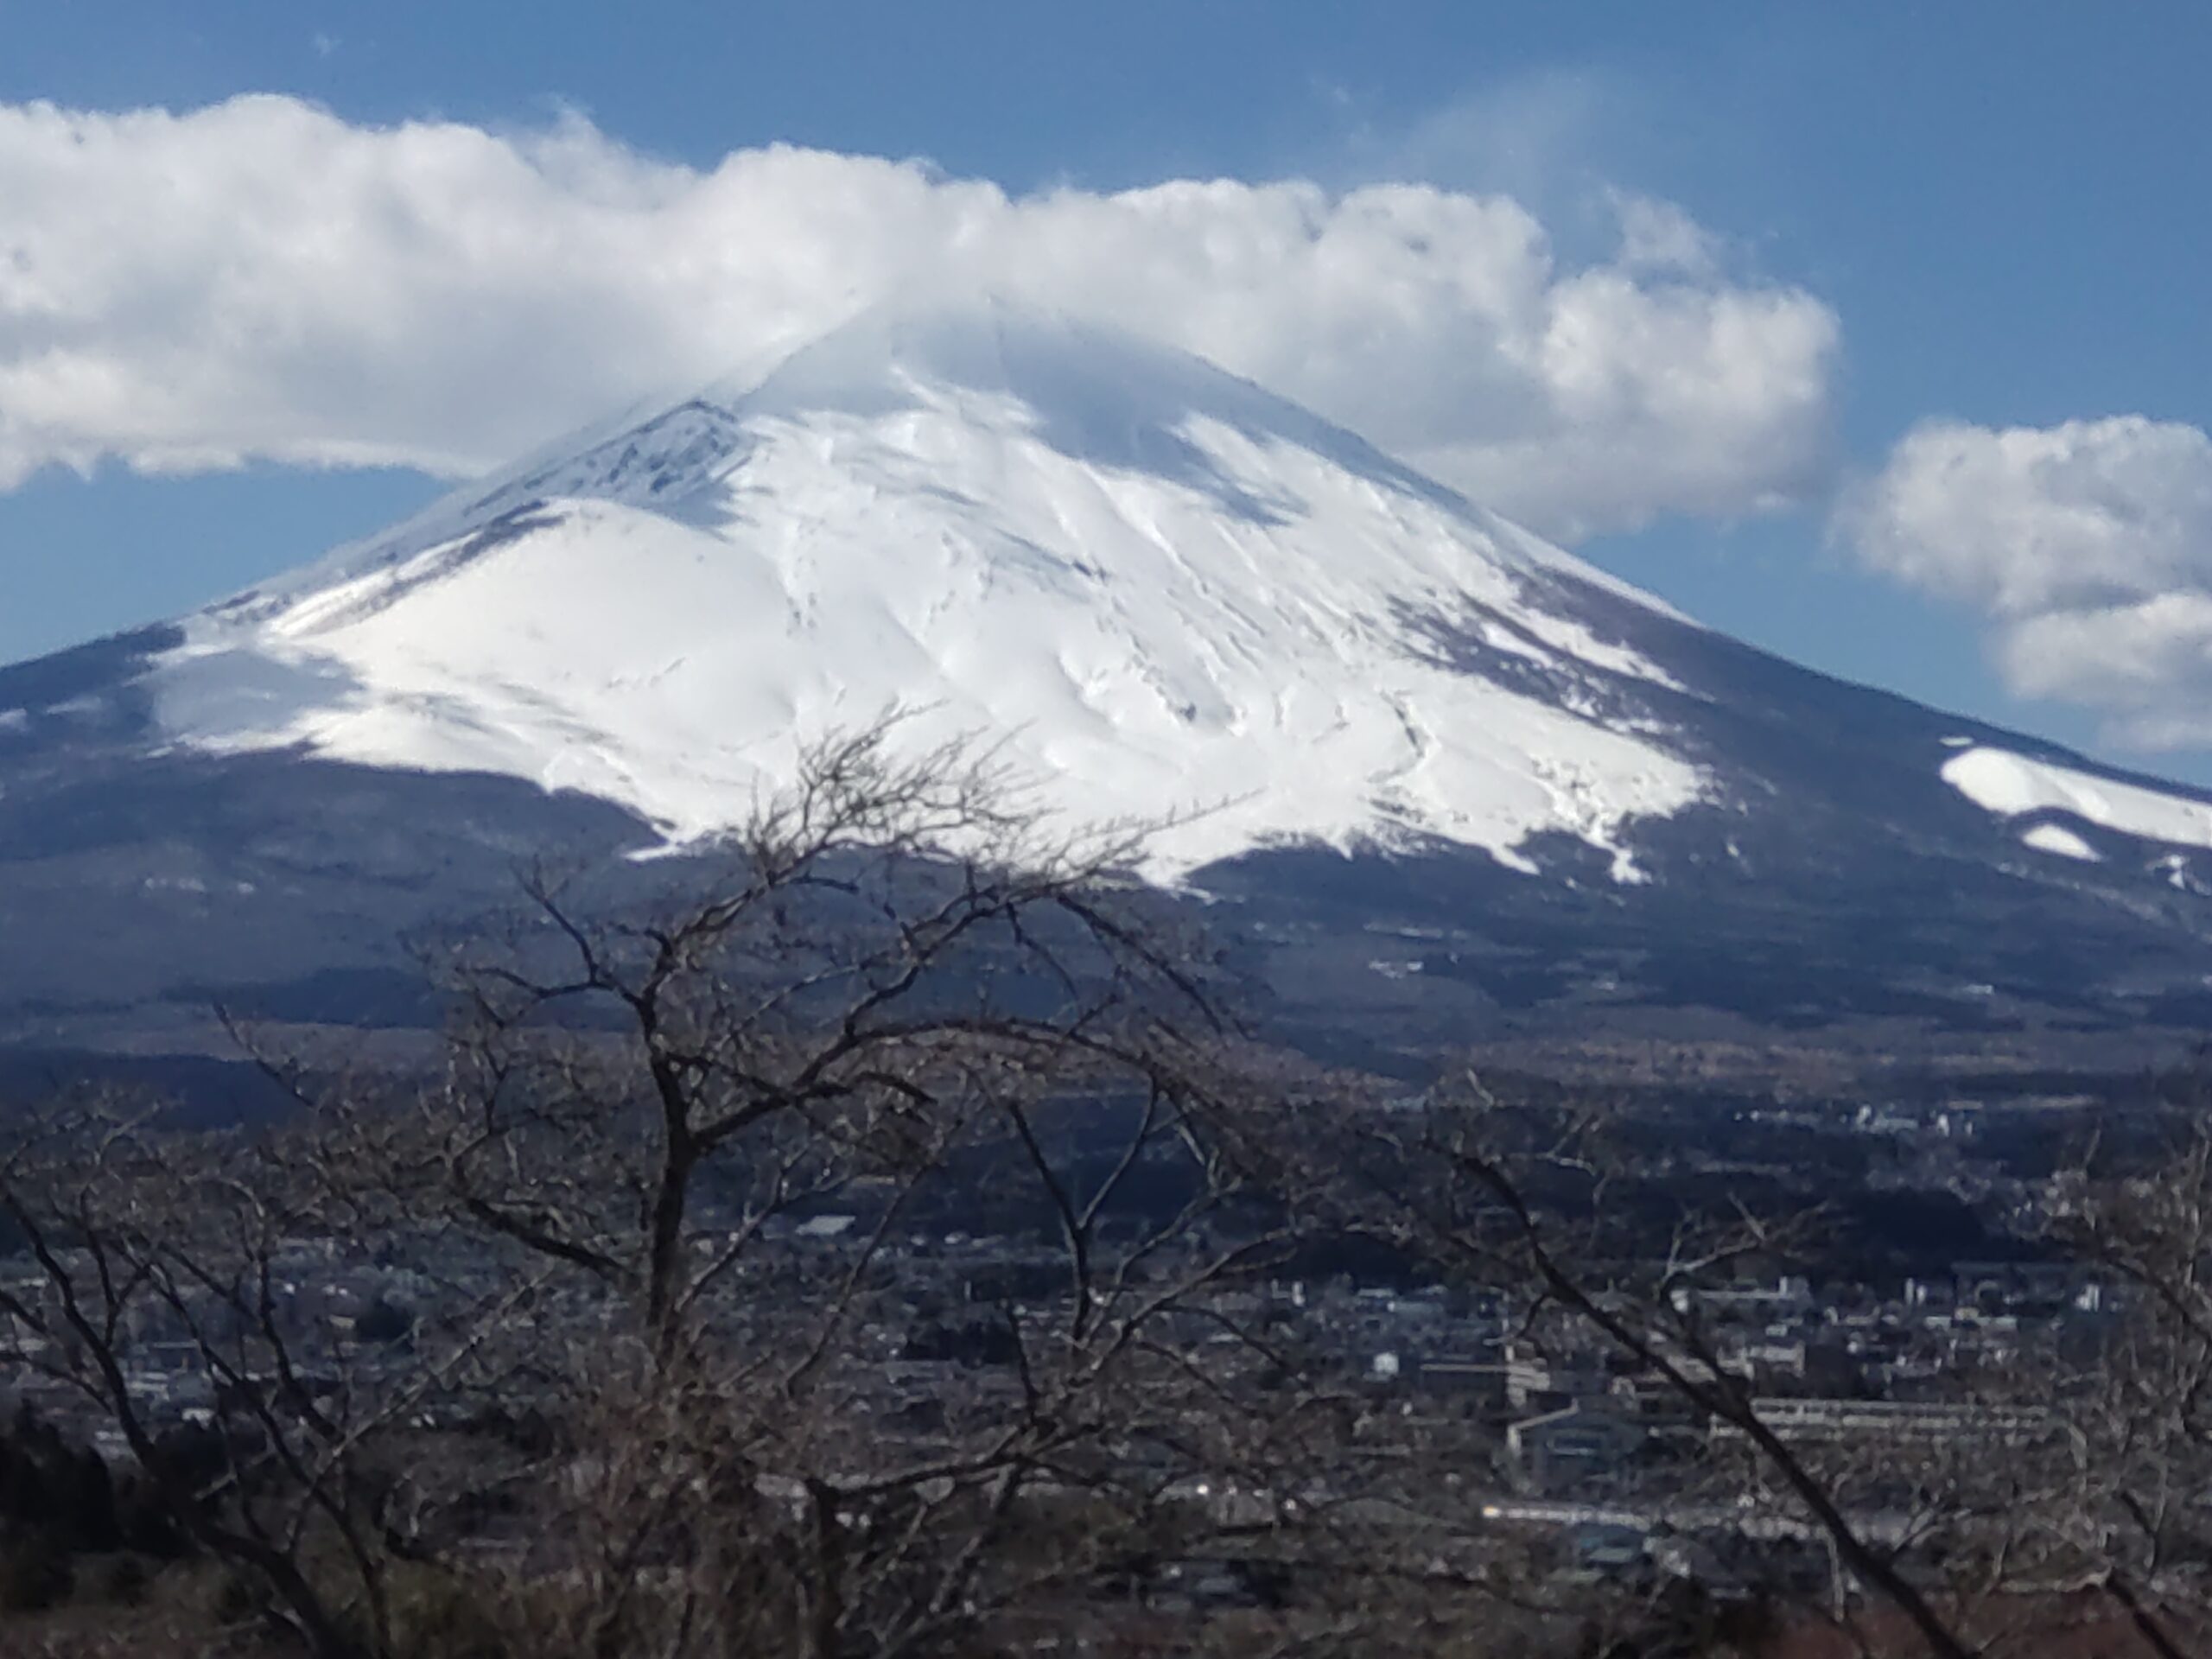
(1840, 416), (2212, 747)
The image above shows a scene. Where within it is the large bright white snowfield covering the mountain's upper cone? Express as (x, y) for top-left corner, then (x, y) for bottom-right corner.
(150, 305), (1710, 880)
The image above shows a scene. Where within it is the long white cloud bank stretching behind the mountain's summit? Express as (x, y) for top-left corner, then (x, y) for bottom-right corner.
(0, 98), (1836, 537)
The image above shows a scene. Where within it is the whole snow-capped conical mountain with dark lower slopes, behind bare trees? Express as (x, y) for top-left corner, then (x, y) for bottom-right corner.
(0, 305), (2212, 1065)
